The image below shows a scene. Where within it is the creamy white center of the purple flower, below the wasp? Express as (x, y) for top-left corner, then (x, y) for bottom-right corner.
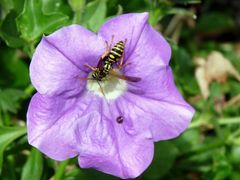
(87, 73), (127, 101)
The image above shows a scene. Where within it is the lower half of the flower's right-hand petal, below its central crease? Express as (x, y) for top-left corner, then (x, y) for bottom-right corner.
(115, 95), (194, 141)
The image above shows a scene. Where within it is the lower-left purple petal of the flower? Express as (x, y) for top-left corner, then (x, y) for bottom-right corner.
(27, 93), (78, 160)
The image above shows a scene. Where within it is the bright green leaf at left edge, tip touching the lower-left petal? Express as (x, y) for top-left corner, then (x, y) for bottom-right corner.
(0, 126), (26, 174)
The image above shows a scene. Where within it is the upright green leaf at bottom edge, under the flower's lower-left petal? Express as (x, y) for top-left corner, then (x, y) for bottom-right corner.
(21, 148), (43, 180)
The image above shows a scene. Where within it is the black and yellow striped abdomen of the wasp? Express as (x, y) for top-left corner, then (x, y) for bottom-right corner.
(105, 41), (125, 64)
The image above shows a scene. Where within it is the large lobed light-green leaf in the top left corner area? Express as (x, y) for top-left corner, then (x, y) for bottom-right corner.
(17, 0), (68, 42)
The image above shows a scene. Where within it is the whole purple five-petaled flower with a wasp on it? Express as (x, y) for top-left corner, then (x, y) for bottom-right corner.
(27, 13), (194, 178)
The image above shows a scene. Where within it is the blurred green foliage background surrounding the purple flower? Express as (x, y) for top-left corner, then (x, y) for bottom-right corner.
(0, 0), (240, 180)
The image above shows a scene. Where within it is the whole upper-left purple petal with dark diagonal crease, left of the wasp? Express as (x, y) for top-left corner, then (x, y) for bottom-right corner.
(30, 25), (105, 96)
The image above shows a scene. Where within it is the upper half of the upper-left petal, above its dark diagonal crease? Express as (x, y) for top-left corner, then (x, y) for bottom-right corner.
(47, 24), (106, 69)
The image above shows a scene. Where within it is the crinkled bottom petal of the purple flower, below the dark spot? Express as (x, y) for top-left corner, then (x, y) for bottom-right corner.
(77, 105), (154, 179)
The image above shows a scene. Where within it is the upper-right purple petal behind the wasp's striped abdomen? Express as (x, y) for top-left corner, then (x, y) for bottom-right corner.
(99, 13), (171, 76)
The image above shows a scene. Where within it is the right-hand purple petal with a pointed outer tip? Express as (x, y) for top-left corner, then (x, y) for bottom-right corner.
(116, 67), (194, 141)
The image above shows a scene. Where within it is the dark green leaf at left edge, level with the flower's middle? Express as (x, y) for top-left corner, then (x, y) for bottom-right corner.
(0, 89), (25, 113)
